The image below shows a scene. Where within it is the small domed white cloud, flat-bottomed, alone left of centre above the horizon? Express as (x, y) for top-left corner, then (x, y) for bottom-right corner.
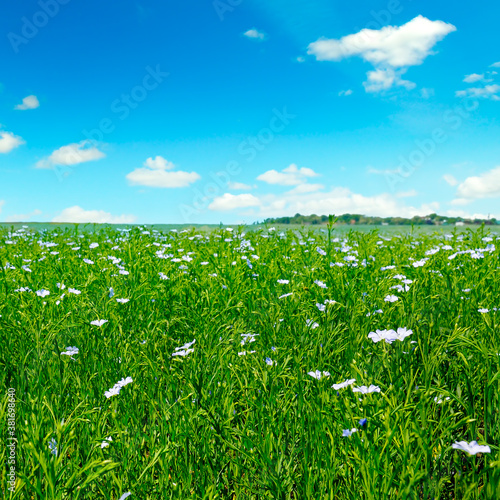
(126, 156), (201, 188)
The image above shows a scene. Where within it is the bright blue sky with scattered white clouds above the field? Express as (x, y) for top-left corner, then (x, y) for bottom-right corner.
(0, 0), (500, 224)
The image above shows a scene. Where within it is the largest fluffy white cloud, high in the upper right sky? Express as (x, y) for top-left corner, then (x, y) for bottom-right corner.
(308, 16), (456, 92)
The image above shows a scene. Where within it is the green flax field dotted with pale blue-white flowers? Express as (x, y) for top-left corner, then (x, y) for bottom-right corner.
(0, 226), (500, 500)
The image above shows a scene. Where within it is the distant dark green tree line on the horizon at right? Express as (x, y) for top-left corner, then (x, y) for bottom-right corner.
(264, 214), (499, 226)
